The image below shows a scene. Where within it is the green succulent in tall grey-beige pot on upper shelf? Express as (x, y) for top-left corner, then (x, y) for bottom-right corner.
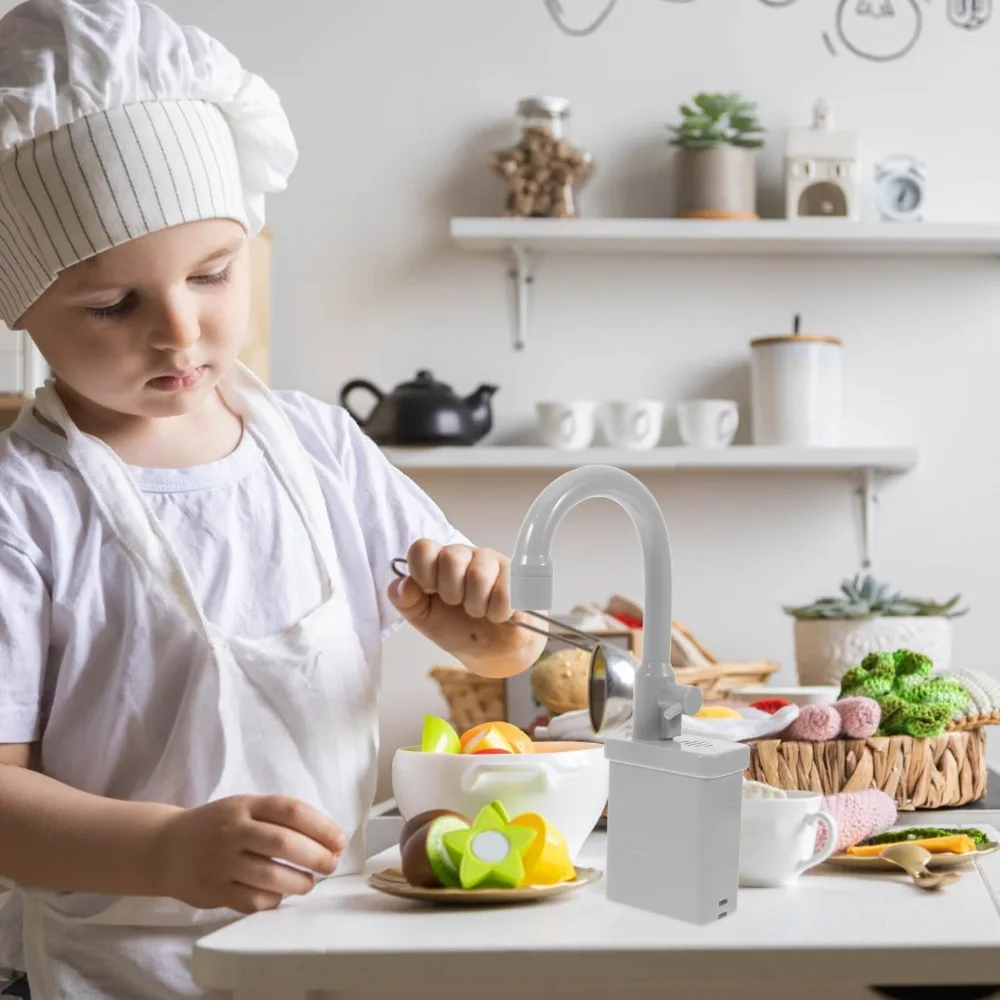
(667, 93), (764, 219)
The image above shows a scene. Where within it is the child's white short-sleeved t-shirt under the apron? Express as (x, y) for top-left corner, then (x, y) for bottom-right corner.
(0, 392), (465, 966)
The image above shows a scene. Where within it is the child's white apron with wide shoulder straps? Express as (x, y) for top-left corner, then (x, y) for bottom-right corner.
(6, 365), (378, 1000)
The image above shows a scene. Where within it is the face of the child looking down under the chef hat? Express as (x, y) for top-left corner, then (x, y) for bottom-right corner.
(19, 219), (250, 417)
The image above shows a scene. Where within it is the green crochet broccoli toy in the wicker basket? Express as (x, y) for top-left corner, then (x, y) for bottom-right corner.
(840, 649), (969, 739)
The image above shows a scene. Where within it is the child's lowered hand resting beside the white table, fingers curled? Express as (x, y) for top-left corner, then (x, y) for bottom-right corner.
(152, 795), (345, 913)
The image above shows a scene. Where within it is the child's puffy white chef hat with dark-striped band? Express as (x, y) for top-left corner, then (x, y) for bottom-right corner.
(0, 0), (298, 326)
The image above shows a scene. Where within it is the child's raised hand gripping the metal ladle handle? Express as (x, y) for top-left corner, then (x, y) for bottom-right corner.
(389, 538), (545, 677)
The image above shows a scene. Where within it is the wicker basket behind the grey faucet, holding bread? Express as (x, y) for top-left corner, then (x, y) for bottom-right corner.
(430, 660), (778, 732)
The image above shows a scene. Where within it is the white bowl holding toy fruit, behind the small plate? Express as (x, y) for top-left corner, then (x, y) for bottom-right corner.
(392, 742), (608, 858)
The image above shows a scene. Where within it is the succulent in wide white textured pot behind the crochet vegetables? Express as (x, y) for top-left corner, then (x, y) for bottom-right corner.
(783, 575), (968, 686)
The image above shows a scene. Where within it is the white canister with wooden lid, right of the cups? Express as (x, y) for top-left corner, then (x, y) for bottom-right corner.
(750, 321), (843, 445)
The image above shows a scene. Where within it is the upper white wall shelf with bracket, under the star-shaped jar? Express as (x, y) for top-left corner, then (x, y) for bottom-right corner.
(451, 217), (1000, 350)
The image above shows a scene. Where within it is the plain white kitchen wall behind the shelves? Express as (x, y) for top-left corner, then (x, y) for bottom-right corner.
(13, 0), (1000, 790)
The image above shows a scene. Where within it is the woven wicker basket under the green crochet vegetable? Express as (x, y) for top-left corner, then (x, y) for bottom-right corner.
(745, 728), (986, 811)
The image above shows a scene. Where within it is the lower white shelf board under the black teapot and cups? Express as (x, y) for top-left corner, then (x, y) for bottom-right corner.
(383, 445), (917, 475)
